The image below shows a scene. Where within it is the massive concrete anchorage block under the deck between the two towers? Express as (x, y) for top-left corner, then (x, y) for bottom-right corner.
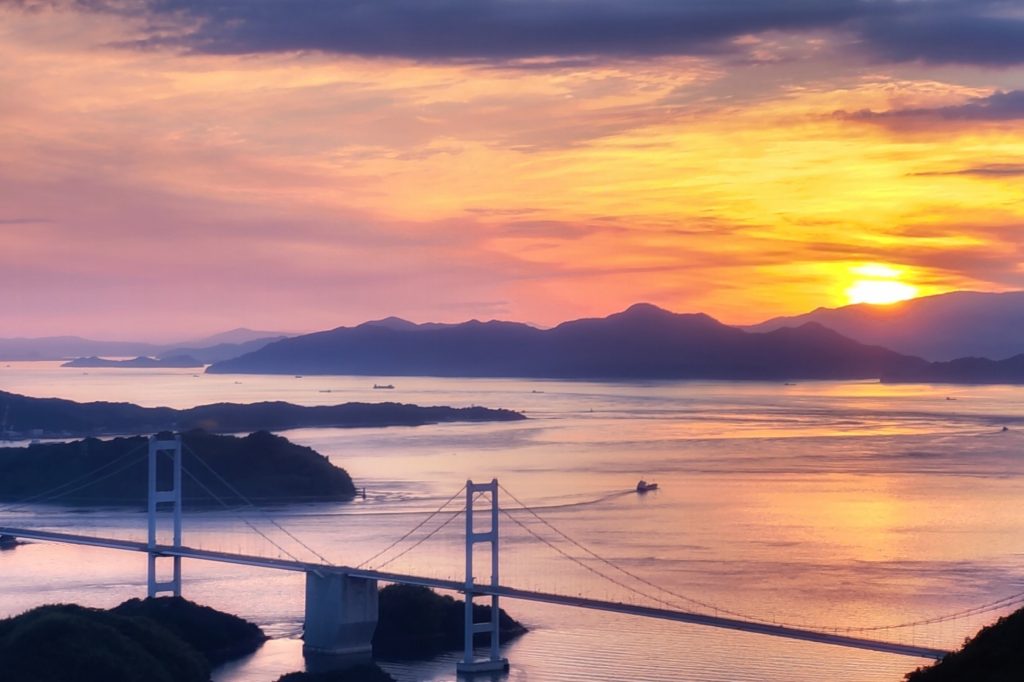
(302, 571), (378, 667)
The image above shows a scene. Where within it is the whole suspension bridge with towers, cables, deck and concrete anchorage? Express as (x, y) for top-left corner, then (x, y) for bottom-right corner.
(0, 436), (1024, 673)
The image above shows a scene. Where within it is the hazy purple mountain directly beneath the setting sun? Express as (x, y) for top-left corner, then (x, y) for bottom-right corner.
(745, 291), (1024, 360)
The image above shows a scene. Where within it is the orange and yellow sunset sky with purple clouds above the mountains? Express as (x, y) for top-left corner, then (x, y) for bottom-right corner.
(0, 0), (1024, 340)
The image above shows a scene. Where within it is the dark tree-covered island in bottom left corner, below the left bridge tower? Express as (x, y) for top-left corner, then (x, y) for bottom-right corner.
(0, 597), (266, 682)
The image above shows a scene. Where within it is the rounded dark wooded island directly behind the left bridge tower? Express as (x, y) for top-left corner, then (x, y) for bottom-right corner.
(0, 430), (355, 506)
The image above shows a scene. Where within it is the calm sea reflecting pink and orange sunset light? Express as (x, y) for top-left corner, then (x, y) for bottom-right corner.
(0, 363), (1024, 682)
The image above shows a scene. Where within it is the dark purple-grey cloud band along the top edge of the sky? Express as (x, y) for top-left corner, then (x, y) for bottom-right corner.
(16, 0), (1024, 67)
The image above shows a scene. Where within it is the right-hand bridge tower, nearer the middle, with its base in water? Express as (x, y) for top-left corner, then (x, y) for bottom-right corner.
(456, 478), (509, 674)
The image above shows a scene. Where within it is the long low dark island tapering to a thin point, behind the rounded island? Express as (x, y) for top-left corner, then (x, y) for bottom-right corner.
(0, 391), (525, 438)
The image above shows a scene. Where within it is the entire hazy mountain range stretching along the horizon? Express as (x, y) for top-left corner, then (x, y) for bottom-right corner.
(8, 292), (1024, 383)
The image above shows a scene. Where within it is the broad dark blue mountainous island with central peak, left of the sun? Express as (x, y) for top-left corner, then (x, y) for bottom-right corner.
(207, 304), (925, 380)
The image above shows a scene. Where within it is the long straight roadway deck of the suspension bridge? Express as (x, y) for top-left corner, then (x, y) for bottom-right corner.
(0, 526), (947, 658)
